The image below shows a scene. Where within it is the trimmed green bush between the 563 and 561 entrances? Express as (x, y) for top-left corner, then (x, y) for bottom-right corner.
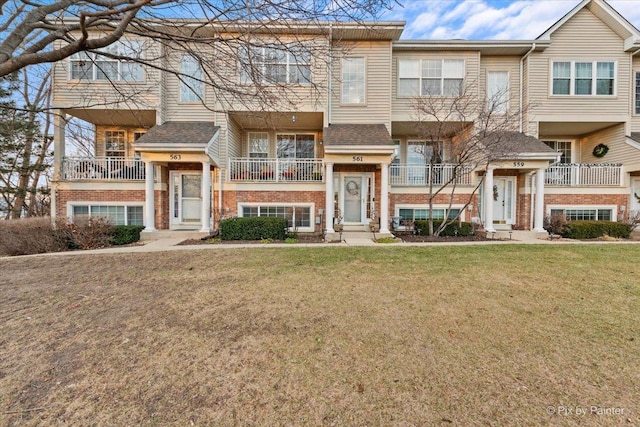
(220, 216), (288, 240)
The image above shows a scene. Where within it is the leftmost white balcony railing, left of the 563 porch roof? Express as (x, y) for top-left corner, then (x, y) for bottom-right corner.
(62, 157), (145, 181)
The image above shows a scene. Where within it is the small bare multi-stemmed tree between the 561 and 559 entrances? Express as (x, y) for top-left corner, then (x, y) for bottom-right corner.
(412, 81), (519, 236)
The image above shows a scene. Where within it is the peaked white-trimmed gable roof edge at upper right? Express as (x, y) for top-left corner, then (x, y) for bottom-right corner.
(537, 0), (640, 52)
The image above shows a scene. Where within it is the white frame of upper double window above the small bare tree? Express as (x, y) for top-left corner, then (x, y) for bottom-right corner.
(396, 58), (467, 98)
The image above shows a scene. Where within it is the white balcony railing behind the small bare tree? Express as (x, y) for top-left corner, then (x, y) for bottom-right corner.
(389, 164), (471, 186)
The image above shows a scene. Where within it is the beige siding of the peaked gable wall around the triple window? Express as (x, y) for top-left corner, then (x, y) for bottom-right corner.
(528, 8), (630, 121)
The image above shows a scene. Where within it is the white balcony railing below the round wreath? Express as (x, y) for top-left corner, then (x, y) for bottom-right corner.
(545, 163), (622, 187)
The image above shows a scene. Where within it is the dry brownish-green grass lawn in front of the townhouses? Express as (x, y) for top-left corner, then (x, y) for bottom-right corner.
(0, 245), (640, 426)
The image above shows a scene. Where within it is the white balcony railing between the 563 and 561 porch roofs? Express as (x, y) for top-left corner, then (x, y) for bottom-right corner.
(229, 158), (322, 182)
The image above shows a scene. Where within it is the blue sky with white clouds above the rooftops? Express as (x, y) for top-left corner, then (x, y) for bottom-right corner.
(381, 0), (640, 40)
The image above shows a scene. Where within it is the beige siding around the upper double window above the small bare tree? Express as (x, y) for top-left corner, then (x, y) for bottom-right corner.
(391, 51), (480, 122)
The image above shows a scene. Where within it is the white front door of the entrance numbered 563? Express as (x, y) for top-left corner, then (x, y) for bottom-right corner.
(170, 172), (202, 226)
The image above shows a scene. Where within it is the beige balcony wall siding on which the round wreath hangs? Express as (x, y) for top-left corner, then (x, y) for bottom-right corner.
(581, 123), (640, 163)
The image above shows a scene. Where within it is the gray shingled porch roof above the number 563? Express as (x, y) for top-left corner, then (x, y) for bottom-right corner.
(136, 122), (220, 144)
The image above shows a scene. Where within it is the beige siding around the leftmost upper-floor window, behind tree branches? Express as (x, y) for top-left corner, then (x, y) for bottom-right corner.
(52, 40), (160, 110)
